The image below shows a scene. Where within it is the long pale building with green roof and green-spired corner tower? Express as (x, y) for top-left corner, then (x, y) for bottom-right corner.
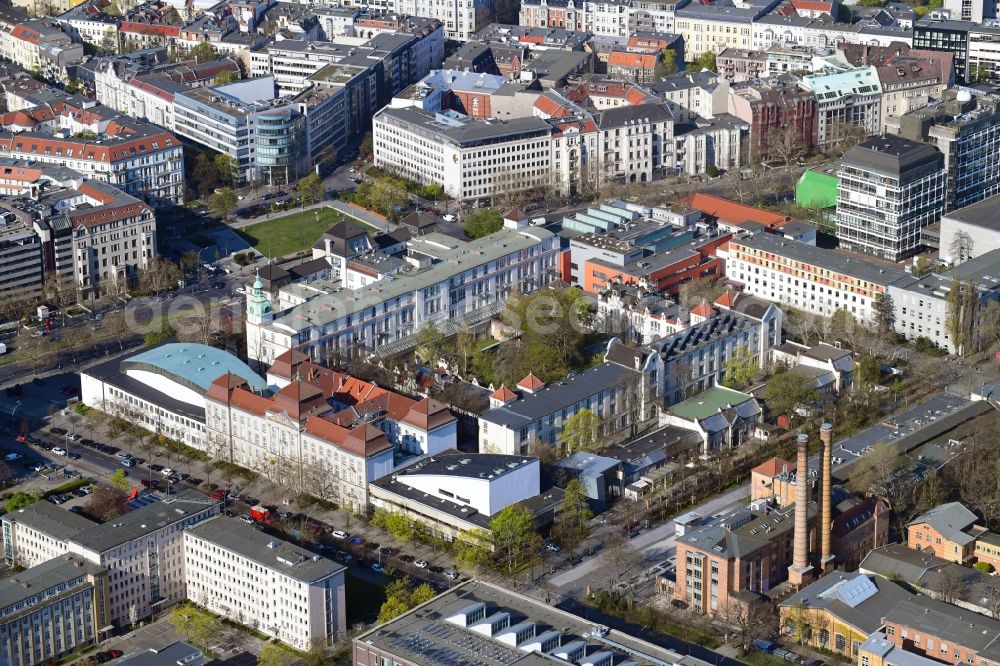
(246, 227), (559, 363)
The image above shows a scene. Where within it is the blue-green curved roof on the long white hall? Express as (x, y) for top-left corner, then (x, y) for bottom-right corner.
(120, 342), (267, 393)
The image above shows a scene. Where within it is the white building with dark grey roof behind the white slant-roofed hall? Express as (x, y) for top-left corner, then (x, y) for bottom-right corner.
(479, 360), (649, 456)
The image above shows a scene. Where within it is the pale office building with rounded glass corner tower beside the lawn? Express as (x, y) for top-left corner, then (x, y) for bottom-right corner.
(174, 77), (308, 186)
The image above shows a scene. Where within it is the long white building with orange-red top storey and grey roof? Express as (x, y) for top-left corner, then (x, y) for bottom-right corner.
(726, 233), (906, 322)
